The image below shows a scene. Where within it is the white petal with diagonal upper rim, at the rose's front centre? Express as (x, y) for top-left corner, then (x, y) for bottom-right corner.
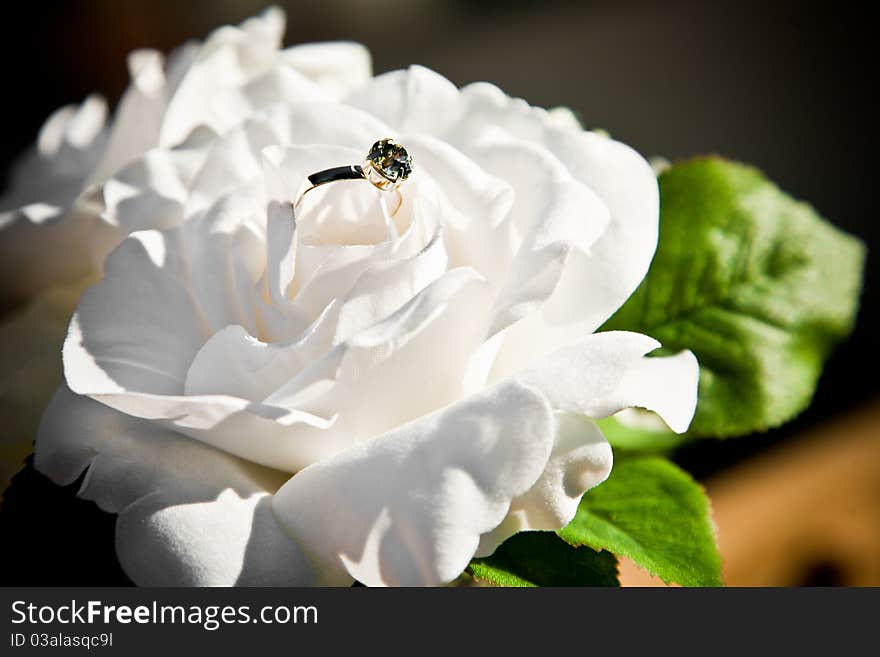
(264, 268), (488, 460)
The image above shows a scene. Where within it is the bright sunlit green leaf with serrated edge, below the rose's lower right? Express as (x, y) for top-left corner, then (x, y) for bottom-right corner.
(559, 456), (721, 586)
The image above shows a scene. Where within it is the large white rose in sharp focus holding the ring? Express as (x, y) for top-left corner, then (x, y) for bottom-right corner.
(35, 9), (697, 585)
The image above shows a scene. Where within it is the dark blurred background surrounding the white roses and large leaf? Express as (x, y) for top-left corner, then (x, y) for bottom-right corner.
(0, 0), (880, 585)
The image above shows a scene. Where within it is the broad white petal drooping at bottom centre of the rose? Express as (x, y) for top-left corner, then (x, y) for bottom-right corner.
(273, 376), (554, 586)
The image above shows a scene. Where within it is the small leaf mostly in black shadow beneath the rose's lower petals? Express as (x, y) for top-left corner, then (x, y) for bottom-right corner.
(470, 532), (620, 586)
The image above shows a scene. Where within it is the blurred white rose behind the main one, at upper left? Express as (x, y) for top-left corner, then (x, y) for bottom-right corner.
(0, 9), (371, 489)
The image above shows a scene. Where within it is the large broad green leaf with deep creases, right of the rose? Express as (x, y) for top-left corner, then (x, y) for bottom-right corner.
(603, 158), (865, 437)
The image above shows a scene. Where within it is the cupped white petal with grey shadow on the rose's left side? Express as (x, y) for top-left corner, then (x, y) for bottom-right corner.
(64, 183), (286, 395)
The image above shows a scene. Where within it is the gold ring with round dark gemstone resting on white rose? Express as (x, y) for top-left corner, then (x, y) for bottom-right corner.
(293, 139), (412, 217)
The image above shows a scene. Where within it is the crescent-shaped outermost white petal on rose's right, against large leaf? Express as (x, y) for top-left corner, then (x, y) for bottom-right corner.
(449, 82), (659, 336)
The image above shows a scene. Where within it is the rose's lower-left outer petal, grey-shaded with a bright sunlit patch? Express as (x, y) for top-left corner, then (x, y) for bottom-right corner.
(35, 387), (342, 586)
